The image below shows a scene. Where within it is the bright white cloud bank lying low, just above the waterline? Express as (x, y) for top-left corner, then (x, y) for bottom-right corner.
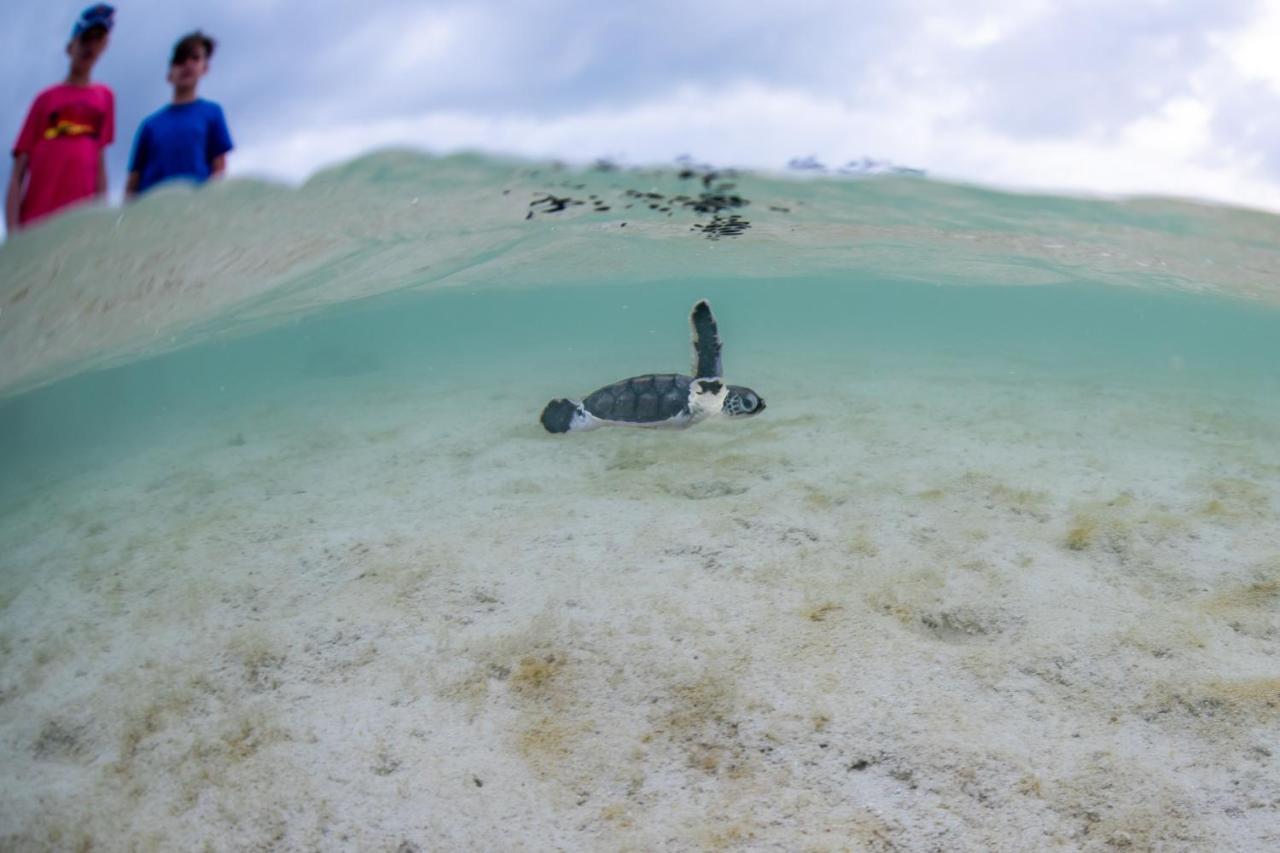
(230, 78), (1280, 212)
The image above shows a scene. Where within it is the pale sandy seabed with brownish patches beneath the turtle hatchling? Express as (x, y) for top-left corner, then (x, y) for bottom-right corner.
(0, 358), (1280, 852)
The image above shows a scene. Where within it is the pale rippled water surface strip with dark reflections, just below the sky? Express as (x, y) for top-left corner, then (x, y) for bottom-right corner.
(0, 151), (1280, 396)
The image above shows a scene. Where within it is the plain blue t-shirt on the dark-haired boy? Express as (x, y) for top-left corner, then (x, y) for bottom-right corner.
(129, 99), (232, 192)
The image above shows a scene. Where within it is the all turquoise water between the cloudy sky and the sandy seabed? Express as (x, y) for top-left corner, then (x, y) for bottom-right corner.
(0, 154), (1280, 494)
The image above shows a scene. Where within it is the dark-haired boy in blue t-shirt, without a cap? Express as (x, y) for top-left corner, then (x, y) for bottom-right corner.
(124, 29), (232, 199)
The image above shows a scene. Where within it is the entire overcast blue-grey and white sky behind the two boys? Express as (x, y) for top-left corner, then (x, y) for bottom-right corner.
(0, 0), (1280, 210)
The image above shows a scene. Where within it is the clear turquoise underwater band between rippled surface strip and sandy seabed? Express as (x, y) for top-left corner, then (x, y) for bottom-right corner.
(0, 266), (1280, 501)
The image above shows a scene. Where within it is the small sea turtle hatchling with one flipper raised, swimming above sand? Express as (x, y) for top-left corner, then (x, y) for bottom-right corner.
(543, 300), (764, 433)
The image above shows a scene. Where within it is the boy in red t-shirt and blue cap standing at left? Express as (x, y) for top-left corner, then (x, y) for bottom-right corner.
(4, 4), (115, 232)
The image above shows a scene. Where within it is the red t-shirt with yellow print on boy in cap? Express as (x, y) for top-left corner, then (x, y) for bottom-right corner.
(13, 83), (115, 224)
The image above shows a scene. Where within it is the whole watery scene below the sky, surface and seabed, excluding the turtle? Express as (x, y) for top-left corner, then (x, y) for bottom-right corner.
(0, 151), (1280, 853)
